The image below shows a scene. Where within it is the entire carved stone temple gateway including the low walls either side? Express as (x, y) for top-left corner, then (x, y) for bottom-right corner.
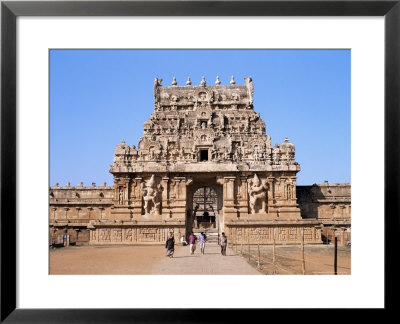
(49, 77), (351, 245)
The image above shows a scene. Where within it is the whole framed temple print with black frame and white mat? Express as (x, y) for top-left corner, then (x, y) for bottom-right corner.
(1, 1), (400, 323)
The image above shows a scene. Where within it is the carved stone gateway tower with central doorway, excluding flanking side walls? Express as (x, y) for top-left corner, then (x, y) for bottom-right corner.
(104, 77), (320, 243)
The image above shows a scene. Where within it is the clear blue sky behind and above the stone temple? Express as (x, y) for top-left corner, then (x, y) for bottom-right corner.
(50, 50), (351, 186)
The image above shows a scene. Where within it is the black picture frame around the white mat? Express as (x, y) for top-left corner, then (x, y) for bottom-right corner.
(0, 0), (400, 323)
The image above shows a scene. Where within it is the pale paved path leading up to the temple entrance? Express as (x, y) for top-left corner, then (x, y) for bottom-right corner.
(152, 243), (261, 275)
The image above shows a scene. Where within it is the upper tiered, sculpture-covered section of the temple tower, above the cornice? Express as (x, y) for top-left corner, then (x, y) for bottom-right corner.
(111, 77), (297, 167)
